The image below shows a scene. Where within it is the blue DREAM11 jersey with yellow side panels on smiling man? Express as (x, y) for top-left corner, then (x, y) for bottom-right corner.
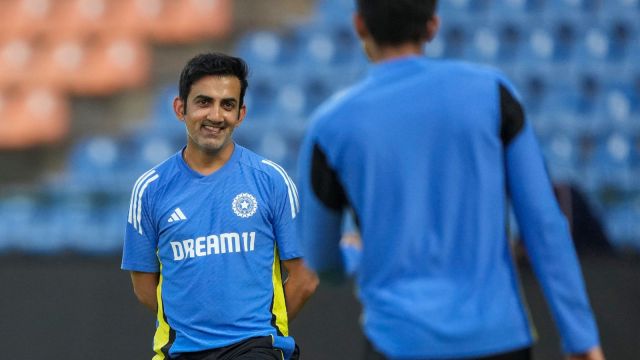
(122, 144), (301, 360)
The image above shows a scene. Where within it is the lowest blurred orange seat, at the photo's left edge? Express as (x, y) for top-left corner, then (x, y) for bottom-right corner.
(0, 88), (69, 149)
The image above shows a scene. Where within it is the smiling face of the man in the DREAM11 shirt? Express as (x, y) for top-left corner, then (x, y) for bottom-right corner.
(174, 76), (246, 155)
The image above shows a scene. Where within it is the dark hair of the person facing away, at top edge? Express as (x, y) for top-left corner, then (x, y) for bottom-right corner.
(357, 0), (438, 46)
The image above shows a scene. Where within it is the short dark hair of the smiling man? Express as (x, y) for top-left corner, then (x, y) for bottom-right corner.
(178, 53), (249, 112)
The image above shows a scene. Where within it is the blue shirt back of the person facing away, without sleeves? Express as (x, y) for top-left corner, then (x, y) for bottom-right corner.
(308, 58), (531, 356)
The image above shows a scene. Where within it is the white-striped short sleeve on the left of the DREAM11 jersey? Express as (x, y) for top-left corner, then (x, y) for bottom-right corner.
(121, 170), (160, 272)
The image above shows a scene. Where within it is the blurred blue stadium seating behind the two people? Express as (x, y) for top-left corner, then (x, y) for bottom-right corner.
(0, 0), (640, 254)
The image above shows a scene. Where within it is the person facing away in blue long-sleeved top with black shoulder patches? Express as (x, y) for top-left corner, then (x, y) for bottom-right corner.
(299, 0), (603, 360)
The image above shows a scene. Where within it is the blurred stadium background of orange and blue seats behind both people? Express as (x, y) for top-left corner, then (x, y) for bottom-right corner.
(0, 0), (640, 360)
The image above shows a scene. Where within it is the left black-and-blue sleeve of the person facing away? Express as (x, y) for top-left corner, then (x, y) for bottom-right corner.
(298, 128), (347, 277)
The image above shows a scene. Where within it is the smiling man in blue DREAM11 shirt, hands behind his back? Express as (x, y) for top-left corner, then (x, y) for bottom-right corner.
(122, 54), (317, 360)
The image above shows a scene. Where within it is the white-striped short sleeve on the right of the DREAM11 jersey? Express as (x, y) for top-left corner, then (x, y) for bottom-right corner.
(262, 160), (302, 260)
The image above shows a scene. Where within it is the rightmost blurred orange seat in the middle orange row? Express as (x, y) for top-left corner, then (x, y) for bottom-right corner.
(71, 34), (151, 96)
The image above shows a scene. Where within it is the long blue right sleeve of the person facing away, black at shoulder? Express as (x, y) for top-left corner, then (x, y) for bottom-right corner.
(500, 81), (599, 353)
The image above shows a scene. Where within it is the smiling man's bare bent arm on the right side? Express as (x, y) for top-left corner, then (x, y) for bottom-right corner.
(282, 258), (319, 321)
